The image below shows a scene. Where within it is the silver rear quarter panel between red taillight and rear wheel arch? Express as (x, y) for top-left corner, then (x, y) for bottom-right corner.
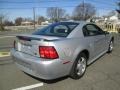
(49, 37), (92, 62)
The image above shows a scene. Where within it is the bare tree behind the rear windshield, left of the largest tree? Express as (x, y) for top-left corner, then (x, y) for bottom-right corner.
(47, 7), (65, 22)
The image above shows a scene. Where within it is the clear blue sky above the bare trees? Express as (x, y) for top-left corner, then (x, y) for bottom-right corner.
(0, 0), (118, 21)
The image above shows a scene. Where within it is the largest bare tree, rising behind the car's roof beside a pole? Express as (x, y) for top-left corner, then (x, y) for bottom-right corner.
(73, 3), (96, 20)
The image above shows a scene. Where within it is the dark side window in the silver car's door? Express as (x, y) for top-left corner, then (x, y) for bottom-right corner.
(83, 24), (103, 36)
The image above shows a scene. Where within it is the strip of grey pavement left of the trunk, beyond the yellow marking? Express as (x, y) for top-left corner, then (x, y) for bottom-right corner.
(0, 30), (34, 51)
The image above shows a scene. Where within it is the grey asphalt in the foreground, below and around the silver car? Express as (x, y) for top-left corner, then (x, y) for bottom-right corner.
(0, 33), (120, 90)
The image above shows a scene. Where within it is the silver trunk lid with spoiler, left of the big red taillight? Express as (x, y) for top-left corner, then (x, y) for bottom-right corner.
(15, 34), (63, 57)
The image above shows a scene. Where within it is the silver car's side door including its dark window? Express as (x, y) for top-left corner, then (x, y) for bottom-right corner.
(85, 24), (106, 57)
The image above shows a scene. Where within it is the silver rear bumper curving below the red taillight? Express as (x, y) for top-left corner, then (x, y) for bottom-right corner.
(11, 49), (71, 80)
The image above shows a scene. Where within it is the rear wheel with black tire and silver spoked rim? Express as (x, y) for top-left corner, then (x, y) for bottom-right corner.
(70, 53), (87, 79)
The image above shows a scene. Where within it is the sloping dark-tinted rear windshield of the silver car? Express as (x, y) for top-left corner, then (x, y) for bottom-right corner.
(33, 22), (79, 37)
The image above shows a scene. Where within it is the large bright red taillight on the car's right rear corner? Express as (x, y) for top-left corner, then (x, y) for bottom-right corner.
(39, 46), (59, 59)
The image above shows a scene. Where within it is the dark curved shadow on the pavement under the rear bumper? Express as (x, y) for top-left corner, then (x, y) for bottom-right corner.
(24, 72), (69, 84)
